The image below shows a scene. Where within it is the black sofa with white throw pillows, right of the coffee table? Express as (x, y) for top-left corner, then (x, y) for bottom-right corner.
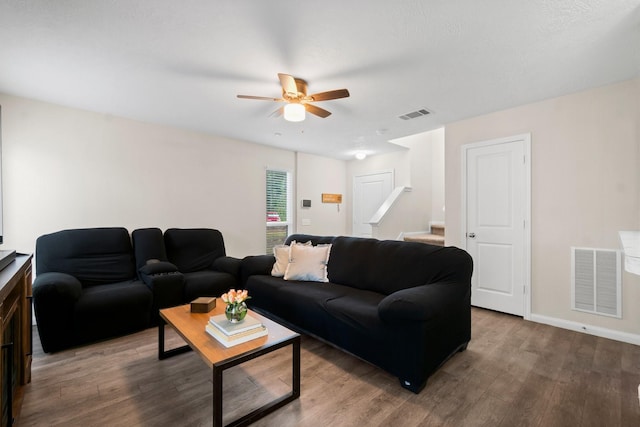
(241, 235), (473, 393)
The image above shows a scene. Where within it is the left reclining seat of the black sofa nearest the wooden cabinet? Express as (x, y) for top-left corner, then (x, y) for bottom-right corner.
(33, 227), (153, 353)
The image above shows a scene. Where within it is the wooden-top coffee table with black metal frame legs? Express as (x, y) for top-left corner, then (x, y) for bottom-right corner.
(158, 299), (300, 427)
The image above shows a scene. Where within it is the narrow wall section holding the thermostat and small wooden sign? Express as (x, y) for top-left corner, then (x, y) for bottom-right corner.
(296, 153), (350, 236)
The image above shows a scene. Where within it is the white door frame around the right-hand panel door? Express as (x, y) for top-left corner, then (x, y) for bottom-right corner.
(460, 133), (531, 320)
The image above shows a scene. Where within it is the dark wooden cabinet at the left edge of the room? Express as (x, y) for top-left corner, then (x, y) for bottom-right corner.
(0, 255), (33, 426)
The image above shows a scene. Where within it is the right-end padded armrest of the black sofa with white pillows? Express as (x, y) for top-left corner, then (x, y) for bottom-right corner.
(378, 282), (470, 323)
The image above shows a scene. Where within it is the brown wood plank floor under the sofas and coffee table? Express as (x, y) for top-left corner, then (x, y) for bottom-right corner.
(17, 308), (640, 427)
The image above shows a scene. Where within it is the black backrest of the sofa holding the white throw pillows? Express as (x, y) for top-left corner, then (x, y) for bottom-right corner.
(290, 234), (471, 295)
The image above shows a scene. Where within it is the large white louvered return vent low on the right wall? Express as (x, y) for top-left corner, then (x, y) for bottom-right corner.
(571, 247), (622, 318)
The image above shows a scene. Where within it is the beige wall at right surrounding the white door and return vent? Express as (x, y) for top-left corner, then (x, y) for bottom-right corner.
(445, 78), (640, 342)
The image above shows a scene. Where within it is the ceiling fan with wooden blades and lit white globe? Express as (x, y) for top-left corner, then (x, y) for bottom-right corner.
(238, 73), (349, 122)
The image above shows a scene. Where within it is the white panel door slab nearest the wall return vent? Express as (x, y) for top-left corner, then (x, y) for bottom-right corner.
(463, 135), (530, 316)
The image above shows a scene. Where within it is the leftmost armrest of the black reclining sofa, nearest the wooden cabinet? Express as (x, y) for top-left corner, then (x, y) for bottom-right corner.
(33, 272), (82, 353)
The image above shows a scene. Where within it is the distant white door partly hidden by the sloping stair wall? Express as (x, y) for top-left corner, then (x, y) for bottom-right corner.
(353, 171), (393, 237)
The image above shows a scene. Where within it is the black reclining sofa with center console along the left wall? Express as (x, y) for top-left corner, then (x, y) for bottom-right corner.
(33, 227), (240, 352)
